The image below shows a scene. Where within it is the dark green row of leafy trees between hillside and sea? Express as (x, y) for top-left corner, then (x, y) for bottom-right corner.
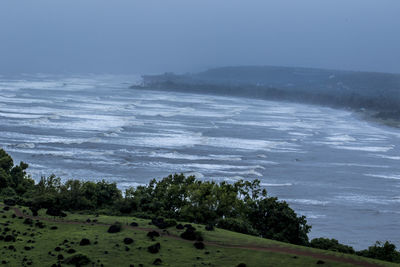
(0, 149), (400, 262)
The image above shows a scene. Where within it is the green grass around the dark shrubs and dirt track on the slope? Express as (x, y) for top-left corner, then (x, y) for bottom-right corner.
(0, 204), (395, 267)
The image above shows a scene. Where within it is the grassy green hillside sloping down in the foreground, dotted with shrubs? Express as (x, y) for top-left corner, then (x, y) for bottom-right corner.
(0, 204), (396, 266)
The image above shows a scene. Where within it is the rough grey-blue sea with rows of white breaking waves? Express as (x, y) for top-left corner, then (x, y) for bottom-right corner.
(0, 75), (400, 249)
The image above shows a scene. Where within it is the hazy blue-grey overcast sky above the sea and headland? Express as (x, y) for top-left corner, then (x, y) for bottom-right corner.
(0, 0), (400, 74)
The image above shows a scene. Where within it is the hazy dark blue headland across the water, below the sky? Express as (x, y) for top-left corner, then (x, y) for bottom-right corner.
(133, 66), (400, 126)
